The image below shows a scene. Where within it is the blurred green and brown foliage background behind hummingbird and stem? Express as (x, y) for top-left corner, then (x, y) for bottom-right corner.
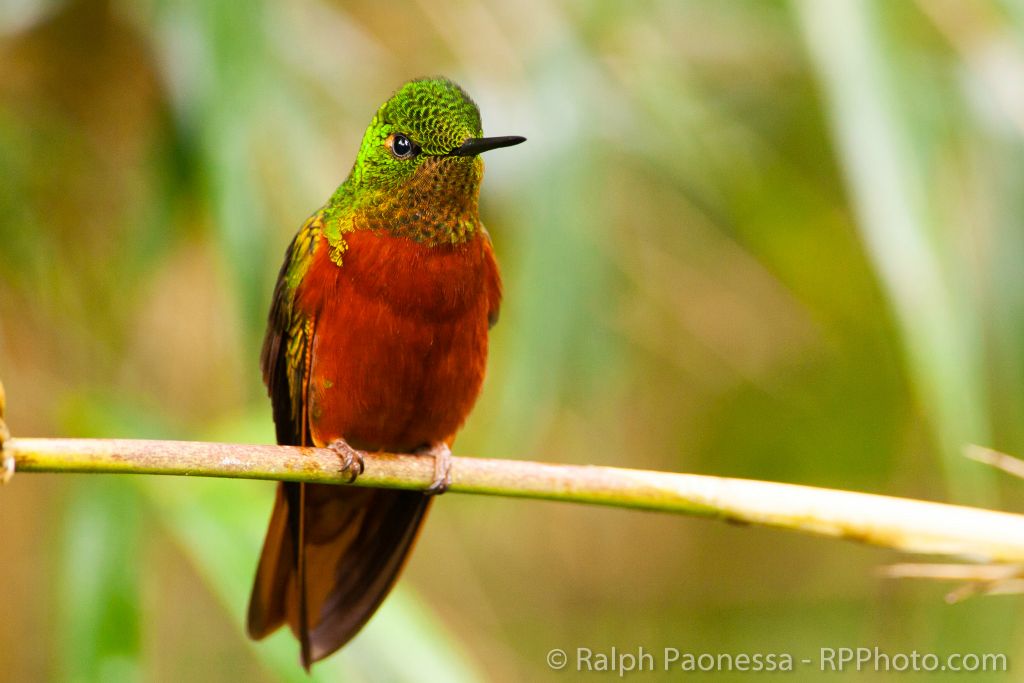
(0, 0), (1024, 681)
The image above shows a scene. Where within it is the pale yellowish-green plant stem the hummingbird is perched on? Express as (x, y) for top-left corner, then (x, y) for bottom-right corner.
(4, 438), (1024, 563)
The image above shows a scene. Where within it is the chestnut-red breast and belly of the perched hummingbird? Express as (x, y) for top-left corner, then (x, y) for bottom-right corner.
(300, 230), (500, 451)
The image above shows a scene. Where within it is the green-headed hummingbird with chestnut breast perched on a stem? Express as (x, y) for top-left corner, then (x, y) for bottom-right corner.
(248, 78), (525, 671)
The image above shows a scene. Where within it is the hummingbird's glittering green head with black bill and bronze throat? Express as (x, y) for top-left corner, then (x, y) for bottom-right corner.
(333, 78), (524, 244)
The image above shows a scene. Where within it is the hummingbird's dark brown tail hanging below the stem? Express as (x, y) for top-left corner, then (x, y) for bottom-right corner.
(248, 483), (431, 670)
